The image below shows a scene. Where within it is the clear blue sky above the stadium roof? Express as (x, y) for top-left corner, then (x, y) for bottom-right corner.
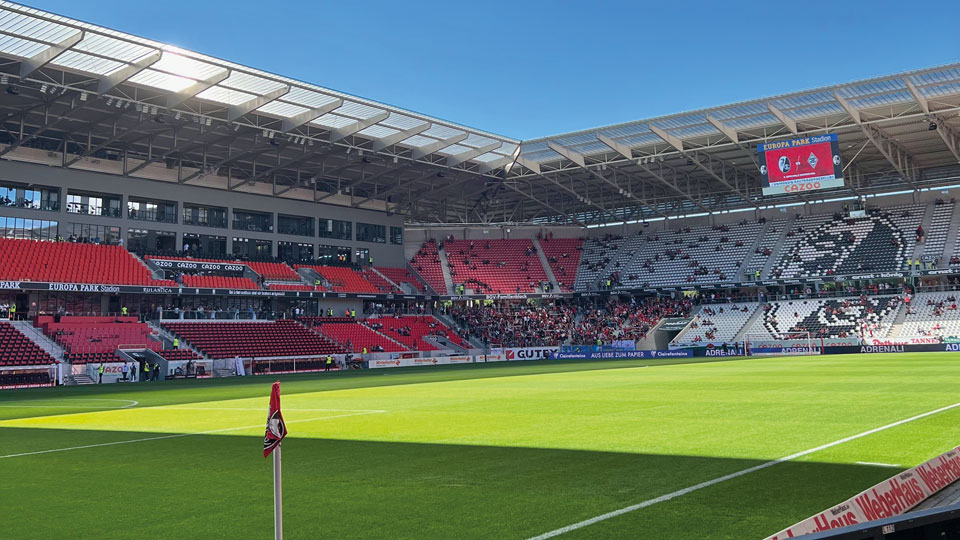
(29, 0), (960, 139)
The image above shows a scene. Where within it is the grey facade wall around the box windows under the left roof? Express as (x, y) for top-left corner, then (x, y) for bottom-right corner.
(0, 161), (405, 266)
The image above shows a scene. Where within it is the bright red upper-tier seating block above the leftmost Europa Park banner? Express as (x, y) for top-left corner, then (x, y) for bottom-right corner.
(0, 238), (177, 287)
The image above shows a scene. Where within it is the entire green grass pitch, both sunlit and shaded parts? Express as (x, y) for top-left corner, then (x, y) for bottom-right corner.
(0, 353), (960, 540)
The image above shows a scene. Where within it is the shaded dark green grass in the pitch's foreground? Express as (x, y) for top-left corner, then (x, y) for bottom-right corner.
(0, 427), (900, 539)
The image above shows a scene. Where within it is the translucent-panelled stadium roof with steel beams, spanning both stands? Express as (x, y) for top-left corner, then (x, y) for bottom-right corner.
(0, 2), (960, 225)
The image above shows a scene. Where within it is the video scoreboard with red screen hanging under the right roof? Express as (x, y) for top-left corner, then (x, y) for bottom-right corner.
(757, 134), (843, 195)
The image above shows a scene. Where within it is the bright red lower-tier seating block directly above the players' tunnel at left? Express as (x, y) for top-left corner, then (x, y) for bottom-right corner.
(34, 316), (163, 364)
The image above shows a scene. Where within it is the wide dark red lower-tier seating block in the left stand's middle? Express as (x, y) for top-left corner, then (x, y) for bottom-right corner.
(163, 320), (345, 359)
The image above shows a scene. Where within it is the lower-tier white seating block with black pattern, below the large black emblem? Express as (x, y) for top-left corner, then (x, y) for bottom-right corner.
(750, 296), (901, 339)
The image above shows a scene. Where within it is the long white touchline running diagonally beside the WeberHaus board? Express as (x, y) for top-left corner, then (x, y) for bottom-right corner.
(528, 403), (960, 540)
